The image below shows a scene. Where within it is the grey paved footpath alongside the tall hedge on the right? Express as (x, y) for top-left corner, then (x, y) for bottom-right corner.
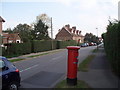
(78, 48), (120, 90)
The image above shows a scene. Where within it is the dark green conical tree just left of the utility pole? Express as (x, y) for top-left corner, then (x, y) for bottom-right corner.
(32, 20), (50, 40)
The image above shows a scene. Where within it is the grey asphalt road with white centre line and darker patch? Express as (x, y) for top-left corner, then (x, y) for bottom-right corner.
(14, 46), (96, 88)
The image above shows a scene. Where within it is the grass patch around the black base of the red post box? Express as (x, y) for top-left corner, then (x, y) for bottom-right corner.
(55, 80), (91, 89)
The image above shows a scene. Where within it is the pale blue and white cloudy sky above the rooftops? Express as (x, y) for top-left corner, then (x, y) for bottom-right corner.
(0, 0), (119, 37)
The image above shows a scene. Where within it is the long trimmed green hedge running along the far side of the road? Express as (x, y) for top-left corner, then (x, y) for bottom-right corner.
(2, 40), (77, 56)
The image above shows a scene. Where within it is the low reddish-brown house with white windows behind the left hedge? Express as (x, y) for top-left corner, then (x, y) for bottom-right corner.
(2, 33), (21, 44)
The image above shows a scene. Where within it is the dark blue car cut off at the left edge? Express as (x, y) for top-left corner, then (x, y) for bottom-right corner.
(0, 56), (21, 90)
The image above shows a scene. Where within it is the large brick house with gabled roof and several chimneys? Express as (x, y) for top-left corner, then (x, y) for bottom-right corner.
(55, 24), (84, 43)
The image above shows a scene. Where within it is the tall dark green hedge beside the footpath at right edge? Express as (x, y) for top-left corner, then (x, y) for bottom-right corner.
(103, 21), (120, 76)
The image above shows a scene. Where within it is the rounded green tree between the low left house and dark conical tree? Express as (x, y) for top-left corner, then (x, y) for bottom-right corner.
(13, 24), (33, 42)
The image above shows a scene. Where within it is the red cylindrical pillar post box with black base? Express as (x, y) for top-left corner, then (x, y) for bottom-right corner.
(67, 46), (80, 85)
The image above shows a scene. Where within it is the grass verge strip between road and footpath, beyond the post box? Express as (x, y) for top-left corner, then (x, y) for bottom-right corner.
(78, 55), (95, 72)
